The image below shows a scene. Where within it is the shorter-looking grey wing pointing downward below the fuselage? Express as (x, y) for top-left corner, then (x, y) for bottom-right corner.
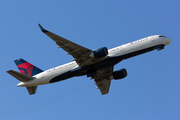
(92, 67), (113, 95)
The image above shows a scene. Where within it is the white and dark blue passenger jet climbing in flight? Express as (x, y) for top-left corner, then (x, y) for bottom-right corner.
(7, 24), (172, 95)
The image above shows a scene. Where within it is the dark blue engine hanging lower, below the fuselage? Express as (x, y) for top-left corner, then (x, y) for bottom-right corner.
(110, 68), (127, 80)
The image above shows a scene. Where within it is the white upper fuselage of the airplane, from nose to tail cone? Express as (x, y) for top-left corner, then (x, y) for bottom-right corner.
(17, 35), (171, 87)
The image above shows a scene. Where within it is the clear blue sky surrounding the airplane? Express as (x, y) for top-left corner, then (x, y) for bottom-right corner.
(0, 0), (180, 120)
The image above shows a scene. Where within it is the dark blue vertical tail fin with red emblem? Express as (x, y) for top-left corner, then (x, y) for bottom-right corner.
(14, 58), (43, 76)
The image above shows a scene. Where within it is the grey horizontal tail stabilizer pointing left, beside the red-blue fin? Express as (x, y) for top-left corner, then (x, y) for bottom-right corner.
(7, 70), (34, 82)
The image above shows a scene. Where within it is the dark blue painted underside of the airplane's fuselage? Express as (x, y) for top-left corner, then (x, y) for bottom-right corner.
(49, 45), (163, 83)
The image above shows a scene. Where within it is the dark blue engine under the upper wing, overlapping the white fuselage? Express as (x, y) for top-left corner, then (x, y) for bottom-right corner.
(90, 47), (108, 58)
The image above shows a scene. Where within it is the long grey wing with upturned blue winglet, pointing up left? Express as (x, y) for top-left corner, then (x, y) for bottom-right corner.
(38, 24), (92, 67)
